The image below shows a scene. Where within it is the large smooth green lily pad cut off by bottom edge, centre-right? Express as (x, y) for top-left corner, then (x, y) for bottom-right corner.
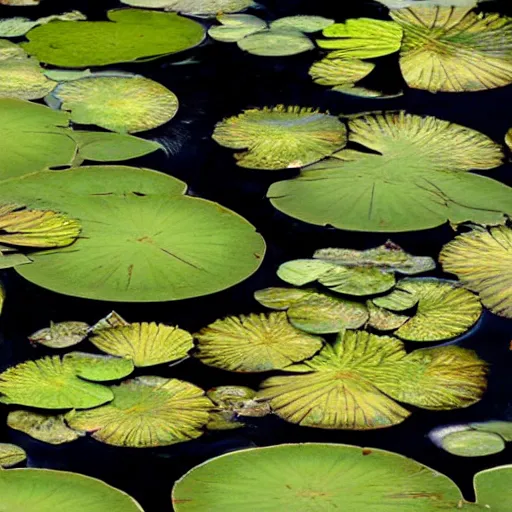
(172, 443), (468, 512)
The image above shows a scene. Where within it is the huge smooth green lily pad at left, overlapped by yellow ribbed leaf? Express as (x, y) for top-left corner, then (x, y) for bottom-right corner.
(0, 166), (265, 302)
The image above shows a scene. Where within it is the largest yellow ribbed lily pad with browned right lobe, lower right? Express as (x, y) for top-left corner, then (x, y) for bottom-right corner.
(258, 331), (486, 430)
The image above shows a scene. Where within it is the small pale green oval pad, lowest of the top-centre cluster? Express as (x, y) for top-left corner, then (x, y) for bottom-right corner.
(237, 28), (315, 57)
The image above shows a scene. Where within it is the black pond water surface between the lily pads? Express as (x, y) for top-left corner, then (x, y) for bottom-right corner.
(0, 0), (512, 512)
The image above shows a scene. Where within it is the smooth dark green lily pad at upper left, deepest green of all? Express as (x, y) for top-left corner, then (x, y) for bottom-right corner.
(22, 9), (205, 68)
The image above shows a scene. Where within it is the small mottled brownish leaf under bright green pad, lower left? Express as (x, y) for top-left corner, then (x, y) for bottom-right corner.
(7, 410), (82, 445)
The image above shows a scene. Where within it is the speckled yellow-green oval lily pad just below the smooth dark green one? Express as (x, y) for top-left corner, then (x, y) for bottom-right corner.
(47, 74), (178, 133)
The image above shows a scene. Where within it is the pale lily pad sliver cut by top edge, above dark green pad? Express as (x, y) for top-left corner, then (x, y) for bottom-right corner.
(121, 0), (254, 16)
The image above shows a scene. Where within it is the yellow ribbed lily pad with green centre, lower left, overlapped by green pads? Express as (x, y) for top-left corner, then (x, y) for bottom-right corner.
(66, 377), (212, 448)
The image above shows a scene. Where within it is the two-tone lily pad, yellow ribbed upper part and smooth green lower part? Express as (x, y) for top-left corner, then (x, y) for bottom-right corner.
(267, 112), (512, 232)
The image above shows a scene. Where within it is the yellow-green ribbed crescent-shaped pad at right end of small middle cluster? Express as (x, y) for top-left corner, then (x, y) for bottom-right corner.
(395, 278), (482, 341)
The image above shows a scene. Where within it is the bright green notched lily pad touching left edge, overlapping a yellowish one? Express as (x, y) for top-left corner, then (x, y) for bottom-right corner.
(0, 357), (113, 409)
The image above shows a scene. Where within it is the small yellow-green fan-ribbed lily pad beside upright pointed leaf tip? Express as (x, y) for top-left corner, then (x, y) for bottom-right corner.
(91, 322), (194, 368)
